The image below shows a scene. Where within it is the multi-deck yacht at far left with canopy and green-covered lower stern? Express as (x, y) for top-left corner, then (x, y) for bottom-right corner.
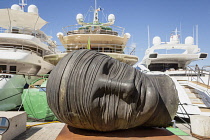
(0, 0), (56, 110)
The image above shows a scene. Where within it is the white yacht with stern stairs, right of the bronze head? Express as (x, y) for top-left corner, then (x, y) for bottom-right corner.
(137, 29), (210, 118)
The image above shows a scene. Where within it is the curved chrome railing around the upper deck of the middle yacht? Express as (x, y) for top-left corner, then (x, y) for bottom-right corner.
(62, 24), (125, 36)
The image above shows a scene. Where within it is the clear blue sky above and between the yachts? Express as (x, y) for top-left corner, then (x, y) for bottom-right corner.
(0, 0), (210, 66)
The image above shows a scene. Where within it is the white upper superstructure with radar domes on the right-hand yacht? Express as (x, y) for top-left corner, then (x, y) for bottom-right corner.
(141, 29), (207, 71)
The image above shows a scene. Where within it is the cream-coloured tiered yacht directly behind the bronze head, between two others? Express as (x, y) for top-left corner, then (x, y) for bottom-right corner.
(45, 1), (138, 65)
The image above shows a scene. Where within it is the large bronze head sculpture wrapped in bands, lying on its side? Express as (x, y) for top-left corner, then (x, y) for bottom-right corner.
(47, 50), (178, 131)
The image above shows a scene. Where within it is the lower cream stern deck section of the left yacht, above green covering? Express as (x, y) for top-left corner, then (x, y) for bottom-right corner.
(0, 49), (54, 75)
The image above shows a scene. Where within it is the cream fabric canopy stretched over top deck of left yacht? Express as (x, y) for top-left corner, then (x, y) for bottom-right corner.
(0, 9), (47, 30)
